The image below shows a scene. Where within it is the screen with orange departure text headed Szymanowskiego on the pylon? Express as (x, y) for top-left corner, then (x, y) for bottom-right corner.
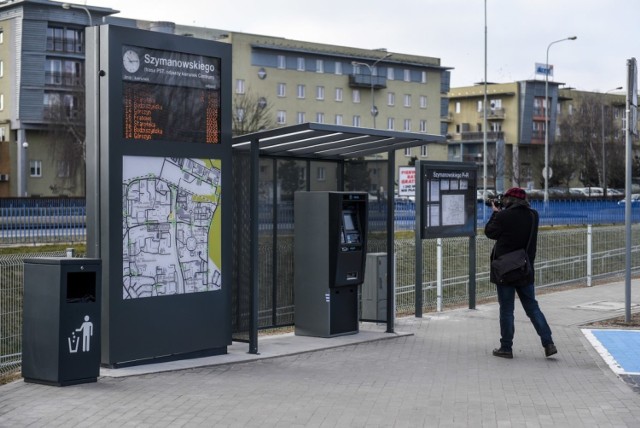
(122, 46), (220, 144)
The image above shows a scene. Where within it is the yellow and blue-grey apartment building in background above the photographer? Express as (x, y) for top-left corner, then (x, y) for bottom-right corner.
(448, 80), (562, 190)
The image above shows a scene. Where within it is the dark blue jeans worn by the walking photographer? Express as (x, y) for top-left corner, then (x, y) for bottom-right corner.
(498, 284), (553, 350)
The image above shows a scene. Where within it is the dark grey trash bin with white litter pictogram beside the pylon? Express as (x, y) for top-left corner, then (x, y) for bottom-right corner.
(22, 258), (101, 386)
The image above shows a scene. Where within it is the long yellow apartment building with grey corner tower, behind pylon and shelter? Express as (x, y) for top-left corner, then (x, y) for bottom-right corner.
(0, 0), (450, 196)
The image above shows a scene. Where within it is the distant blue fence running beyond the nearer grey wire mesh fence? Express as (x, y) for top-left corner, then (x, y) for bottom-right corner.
(0, 198), (640, 244)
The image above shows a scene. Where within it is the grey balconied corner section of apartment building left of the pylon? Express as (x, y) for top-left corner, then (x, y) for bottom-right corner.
(0, 0), (117, 196)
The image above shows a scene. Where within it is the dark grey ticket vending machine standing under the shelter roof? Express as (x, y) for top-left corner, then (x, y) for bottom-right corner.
(294, 192), (367, 337)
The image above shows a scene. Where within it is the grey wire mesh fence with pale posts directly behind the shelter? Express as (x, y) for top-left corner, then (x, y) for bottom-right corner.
(0, 224), (640, 377)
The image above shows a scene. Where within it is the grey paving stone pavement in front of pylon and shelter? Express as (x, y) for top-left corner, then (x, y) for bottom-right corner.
(0, 281), (640, 427)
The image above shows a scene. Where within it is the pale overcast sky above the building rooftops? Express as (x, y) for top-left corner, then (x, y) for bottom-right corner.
(89, 0), (640, 91)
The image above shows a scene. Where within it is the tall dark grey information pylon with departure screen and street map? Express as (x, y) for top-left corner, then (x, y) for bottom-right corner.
(86, 25), (232, 367)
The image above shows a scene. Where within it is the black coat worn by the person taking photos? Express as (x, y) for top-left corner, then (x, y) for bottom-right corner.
(484, 201), (539, 286)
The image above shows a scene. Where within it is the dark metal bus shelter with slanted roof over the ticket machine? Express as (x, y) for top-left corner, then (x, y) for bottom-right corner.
(232, 123), (446, 353)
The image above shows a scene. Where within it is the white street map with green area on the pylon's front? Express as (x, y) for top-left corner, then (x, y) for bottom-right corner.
(122, 156), (221, 299)
